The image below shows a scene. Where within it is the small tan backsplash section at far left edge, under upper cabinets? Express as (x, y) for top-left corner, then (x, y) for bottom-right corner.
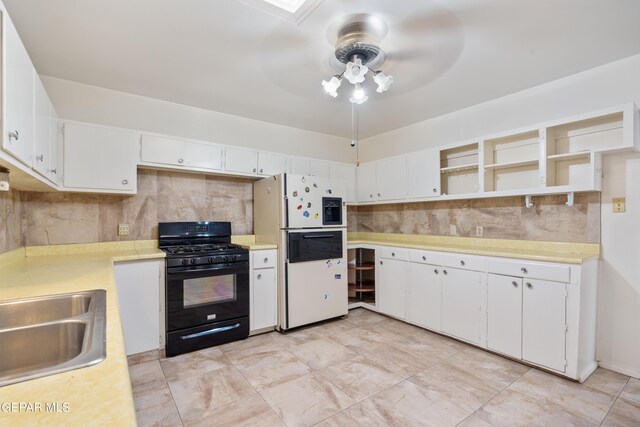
(0, 190), (26, 253)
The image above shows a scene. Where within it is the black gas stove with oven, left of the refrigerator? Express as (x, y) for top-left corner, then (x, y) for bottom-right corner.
(158, 221), (249, 356)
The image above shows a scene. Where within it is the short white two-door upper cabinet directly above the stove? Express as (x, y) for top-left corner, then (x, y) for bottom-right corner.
(140, 134), (222, 171)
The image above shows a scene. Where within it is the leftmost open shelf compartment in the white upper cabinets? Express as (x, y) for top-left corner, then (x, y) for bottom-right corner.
(440, 143), (480, 195)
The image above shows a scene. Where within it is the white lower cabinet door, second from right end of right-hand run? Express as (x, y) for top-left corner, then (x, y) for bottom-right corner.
(487, 274), (522, 359)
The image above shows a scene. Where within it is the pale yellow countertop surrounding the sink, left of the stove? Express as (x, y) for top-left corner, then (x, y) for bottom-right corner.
(0, 241), (165, 426)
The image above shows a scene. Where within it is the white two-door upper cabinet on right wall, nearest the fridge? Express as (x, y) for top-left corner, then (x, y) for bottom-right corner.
(357, 156), (407, 202)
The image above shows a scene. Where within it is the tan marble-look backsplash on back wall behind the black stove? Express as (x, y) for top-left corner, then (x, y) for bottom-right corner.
(25, 170), (253, 246)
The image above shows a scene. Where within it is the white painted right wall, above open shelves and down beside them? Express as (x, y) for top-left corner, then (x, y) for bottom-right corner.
(360, 55), (640, 377)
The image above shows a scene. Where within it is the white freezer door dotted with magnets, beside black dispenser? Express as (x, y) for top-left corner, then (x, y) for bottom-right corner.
(286, 174), (326, 228)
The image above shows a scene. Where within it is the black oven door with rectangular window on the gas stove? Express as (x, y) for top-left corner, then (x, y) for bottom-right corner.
(166, 262), (249, 331)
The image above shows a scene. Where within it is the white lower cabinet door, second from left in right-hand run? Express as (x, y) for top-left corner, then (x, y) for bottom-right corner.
(407, 262), (442, 331)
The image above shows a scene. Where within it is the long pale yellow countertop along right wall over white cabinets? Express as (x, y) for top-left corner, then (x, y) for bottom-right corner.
(348, 232), (600, 264)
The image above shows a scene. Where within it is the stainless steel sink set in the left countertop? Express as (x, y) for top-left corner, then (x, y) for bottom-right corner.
(0, 289), (106, 386)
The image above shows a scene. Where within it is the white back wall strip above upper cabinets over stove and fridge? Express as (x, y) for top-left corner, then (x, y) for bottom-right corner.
(41, 76), (355, 162)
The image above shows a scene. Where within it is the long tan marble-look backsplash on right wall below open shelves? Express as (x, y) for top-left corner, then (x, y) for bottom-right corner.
(348, 192), (600, 243)
